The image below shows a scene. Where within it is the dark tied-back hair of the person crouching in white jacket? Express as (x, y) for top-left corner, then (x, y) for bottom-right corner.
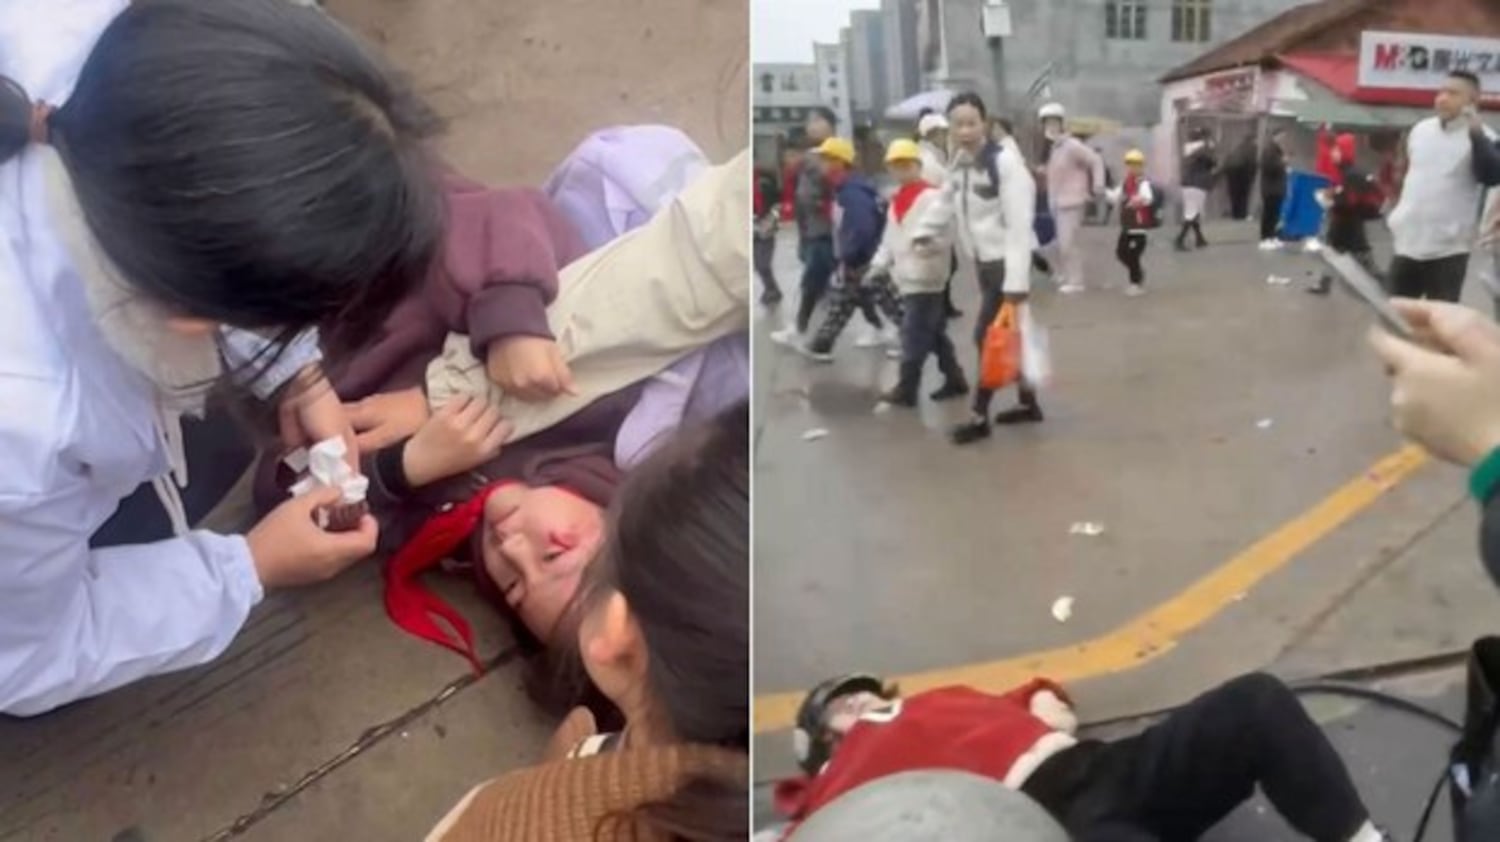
(0, 0), (443, 367)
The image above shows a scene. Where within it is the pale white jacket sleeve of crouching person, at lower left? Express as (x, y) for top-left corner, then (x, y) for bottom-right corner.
(0, 389), (263, 716)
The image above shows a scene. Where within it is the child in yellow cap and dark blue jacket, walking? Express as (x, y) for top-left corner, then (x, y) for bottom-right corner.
(792, 138), (902, 362)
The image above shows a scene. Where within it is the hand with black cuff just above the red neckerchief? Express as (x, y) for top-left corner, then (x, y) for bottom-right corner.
(401, 396), (515, 488)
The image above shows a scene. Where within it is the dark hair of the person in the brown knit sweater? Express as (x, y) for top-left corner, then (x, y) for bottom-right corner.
(582, 402), (750, 842)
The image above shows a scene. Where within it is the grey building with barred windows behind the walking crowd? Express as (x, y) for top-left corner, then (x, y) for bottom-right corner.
(918, 0), (1307, 126)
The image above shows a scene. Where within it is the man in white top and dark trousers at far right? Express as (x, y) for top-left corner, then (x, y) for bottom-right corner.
(1389, 71), (1500, 302)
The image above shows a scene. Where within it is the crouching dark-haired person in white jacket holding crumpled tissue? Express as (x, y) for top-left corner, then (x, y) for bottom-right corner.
(0, 0), (443, 716)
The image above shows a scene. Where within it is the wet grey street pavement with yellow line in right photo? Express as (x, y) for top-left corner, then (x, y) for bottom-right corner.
(756, 217), (1500, 839)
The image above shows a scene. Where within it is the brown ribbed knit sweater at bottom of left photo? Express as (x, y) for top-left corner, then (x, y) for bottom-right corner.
(428, 746), (749, 842)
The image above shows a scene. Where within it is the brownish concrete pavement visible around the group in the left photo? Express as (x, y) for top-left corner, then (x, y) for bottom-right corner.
(0, 0), (749, 842)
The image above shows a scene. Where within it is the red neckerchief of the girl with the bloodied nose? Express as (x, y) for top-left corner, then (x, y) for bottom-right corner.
(386, 480), (516, 674)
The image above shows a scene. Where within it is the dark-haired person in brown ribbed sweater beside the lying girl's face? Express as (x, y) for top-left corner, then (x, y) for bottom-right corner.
(428, 404), (750, 842)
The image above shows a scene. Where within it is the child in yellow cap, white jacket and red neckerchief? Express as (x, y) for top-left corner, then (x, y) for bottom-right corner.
(870, 138), (969, 407)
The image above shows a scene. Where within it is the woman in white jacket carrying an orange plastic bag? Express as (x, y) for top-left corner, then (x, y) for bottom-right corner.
(915, 93), (1044, 444)
